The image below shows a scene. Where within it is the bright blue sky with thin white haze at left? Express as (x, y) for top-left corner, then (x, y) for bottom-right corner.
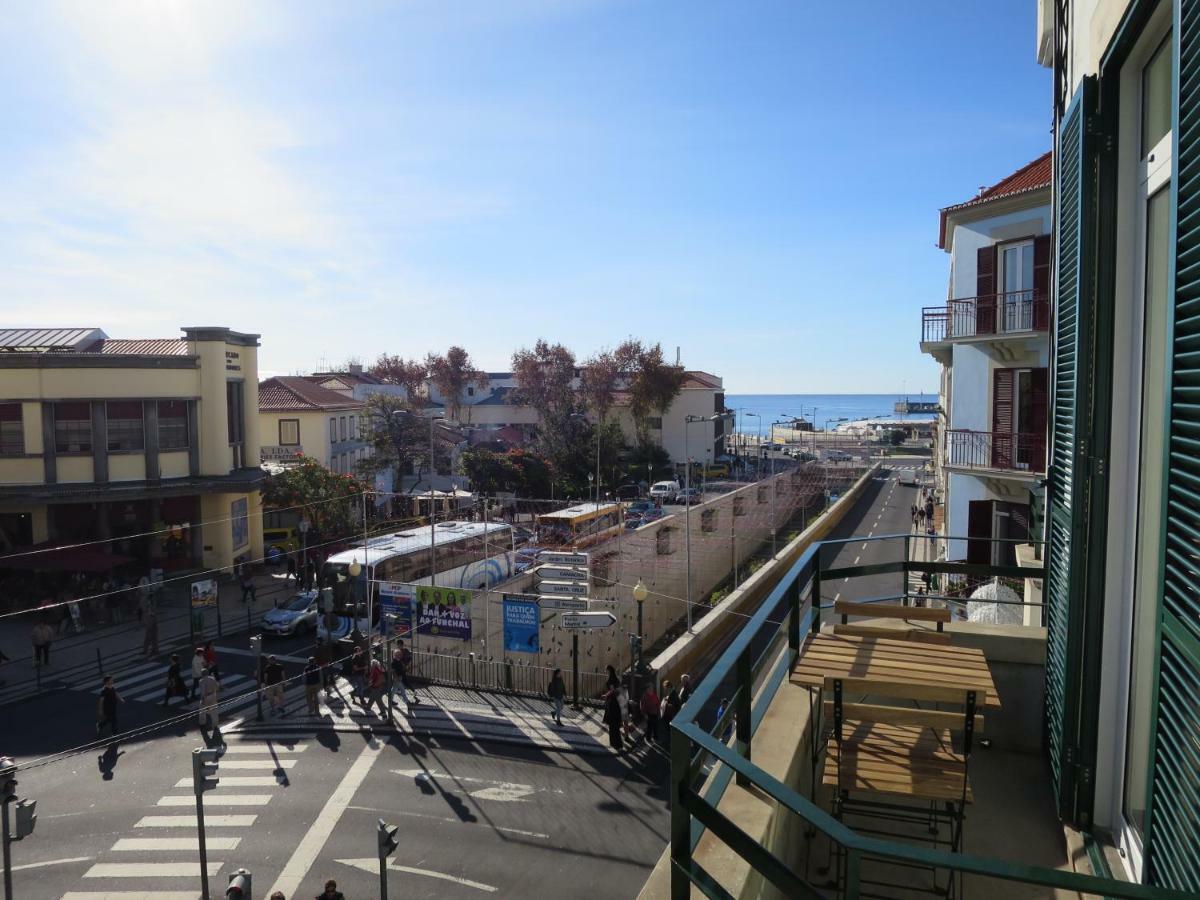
(0, 0), (1050, 392)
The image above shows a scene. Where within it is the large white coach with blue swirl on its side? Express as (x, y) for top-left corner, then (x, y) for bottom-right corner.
(317, 522), (515, 641)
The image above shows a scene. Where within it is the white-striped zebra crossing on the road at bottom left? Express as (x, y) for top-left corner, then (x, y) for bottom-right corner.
(60, 737), (308, 900)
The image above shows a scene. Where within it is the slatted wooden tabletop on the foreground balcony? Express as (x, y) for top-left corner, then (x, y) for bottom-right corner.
(791, 632), (1000, 709)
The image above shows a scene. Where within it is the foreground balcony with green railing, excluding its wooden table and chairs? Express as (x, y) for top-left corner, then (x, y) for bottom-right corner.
(641, 535), (1187, 900)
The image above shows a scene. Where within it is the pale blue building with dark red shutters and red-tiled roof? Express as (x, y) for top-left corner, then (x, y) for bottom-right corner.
(920, 152), (1051, 565)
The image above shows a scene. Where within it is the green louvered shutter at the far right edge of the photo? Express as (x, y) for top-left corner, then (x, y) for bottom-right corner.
(1146, 0), (1200, 892)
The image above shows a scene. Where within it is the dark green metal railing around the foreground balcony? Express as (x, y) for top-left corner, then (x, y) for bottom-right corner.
(670, 535), (1192, 900)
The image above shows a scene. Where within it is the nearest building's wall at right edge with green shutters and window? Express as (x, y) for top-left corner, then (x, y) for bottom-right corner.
(1038, 0), (1200, 892)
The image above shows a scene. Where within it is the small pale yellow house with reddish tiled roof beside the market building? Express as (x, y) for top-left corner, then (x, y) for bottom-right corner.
(258, 376), (371, 474)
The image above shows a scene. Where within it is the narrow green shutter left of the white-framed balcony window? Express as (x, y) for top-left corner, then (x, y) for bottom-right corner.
(1045, 78), (1096, 821)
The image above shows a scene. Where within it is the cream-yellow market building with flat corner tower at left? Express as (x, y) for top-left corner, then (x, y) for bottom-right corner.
(0, 328), (263, 571)
